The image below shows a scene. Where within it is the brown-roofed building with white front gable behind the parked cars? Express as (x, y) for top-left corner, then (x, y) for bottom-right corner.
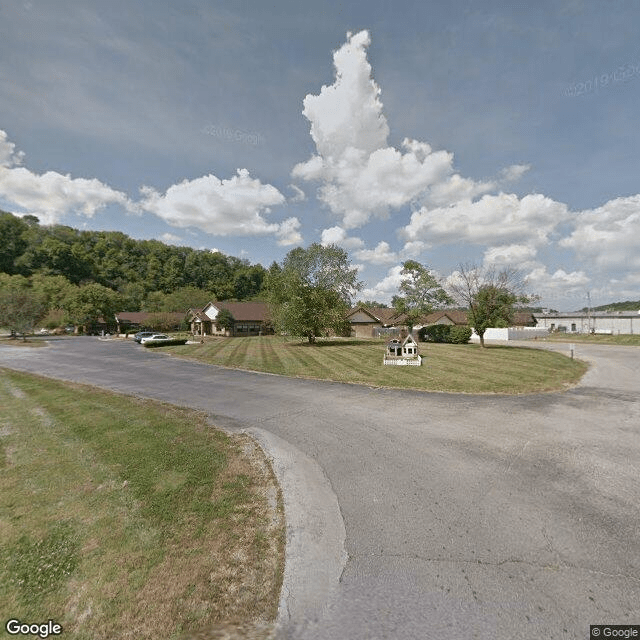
(189, 301), (273, 336)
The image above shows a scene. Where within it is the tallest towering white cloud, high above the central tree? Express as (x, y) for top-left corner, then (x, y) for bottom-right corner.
(292, 31), (453, 229)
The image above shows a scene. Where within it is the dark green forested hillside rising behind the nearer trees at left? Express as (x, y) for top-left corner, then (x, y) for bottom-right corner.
(0, 211), (267, 311)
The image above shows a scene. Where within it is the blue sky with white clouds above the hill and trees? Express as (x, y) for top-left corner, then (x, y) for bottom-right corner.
(0, 0), (640, 311)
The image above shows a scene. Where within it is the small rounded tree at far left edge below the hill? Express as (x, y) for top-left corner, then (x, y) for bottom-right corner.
(0, 276), (47, 341)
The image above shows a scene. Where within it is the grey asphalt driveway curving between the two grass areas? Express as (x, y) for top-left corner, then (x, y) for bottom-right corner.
(0, 338), (640, 640)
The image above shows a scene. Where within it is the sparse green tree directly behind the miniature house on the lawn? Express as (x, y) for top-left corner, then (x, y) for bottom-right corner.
(392, 260), (452, 331)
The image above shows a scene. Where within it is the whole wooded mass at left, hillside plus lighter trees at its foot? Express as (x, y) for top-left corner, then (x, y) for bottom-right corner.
(0, 211), (266, 336)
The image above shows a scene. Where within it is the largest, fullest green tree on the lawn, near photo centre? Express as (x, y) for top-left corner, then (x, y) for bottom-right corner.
(267, 243), (362, 343)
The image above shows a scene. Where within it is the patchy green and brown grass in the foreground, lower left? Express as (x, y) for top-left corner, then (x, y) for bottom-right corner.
(0, 369), (284, 640)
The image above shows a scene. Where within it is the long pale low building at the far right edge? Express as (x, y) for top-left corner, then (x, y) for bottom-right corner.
(534, 310), (640, 335)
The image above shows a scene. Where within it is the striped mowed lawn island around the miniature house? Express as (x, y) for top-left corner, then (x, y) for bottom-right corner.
(163, 336), (587, 394)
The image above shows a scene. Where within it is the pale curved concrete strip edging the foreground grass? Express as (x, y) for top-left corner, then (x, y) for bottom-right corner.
(244, 428), (347, 637)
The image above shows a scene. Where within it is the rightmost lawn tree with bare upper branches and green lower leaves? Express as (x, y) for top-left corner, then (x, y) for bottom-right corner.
(449, 264), (532, 347)
